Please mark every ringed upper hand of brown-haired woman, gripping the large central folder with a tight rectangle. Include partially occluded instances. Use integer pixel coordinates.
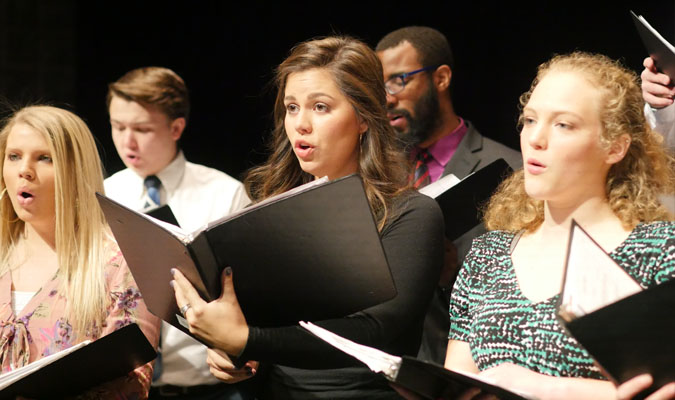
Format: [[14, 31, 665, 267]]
[[171, 267, 248, 356]]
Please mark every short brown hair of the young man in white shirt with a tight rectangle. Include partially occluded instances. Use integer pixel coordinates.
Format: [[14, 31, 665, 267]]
[[107, 67, 190, 121]]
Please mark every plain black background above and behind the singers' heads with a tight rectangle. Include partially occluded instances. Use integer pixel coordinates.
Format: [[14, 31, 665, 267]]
[[0, 0, 675, 178]]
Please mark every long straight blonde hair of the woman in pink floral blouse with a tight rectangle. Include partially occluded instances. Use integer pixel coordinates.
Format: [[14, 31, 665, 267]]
[[0, 106, 111, 336]]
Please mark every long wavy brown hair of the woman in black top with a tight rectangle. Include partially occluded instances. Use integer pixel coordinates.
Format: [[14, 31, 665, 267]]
[[244, 37, 408, 230]]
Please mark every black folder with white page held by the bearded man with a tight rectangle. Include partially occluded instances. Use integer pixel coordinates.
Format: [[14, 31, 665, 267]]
[[419, 158, 513, 240]]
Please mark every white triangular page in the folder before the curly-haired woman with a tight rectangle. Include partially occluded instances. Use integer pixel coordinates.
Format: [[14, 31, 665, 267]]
[[561, 225, 642, 317]]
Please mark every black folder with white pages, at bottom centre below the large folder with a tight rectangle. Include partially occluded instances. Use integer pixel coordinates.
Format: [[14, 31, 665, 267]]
[[300, 322, 534, 400]]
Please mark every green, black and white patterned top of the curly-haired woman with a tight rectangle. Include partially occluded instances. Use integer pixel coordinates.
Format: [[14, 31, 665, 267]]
[[449, 222, 675, 379]]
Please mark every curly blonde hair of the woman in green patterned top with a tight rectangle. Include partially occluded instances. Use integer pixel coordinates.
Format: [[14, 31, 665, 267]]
[[484, 52, 675, 232]]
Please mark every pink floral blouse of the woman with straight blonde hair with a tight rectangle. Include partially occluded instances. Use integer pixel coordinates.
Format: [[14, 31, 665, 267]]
[[0, 245, 160, 399]]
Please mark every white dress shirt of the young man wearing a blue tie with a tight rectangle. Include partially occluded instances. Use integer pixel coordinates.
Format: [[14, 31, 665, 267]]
[[105, 152, 250, 386]]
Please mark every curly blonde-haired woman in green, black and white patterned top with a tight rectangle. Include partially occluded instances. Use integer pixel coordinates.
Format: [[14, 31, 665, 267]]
[[446, 52, 675, 400]]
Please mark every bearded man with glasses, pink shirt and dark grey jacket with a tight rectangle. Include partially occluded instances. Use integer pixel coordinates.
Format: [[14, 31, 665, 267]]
[[375, 26, 522, 364]]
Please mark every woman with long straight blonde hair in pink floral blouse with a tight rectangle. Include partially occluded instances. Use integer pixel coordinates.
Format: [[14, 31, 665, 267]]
[[0, 106, 159, 398]]
